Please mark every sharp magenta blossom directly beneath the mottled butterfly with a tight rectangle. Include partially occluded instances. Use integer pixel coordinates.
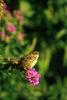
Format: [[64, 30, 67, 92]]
[[25, 68, 41, 86]]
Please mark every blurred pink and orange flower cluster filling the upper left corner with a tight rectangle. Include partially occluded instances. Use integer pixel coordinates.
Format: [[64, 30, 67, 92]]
[[0, 0, 26, 45]]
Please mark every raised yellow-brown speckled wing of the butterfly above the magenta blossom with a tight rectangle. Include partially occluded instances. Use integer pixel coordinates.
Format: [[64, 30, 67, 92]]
[[18, 51, 39, 69]]
